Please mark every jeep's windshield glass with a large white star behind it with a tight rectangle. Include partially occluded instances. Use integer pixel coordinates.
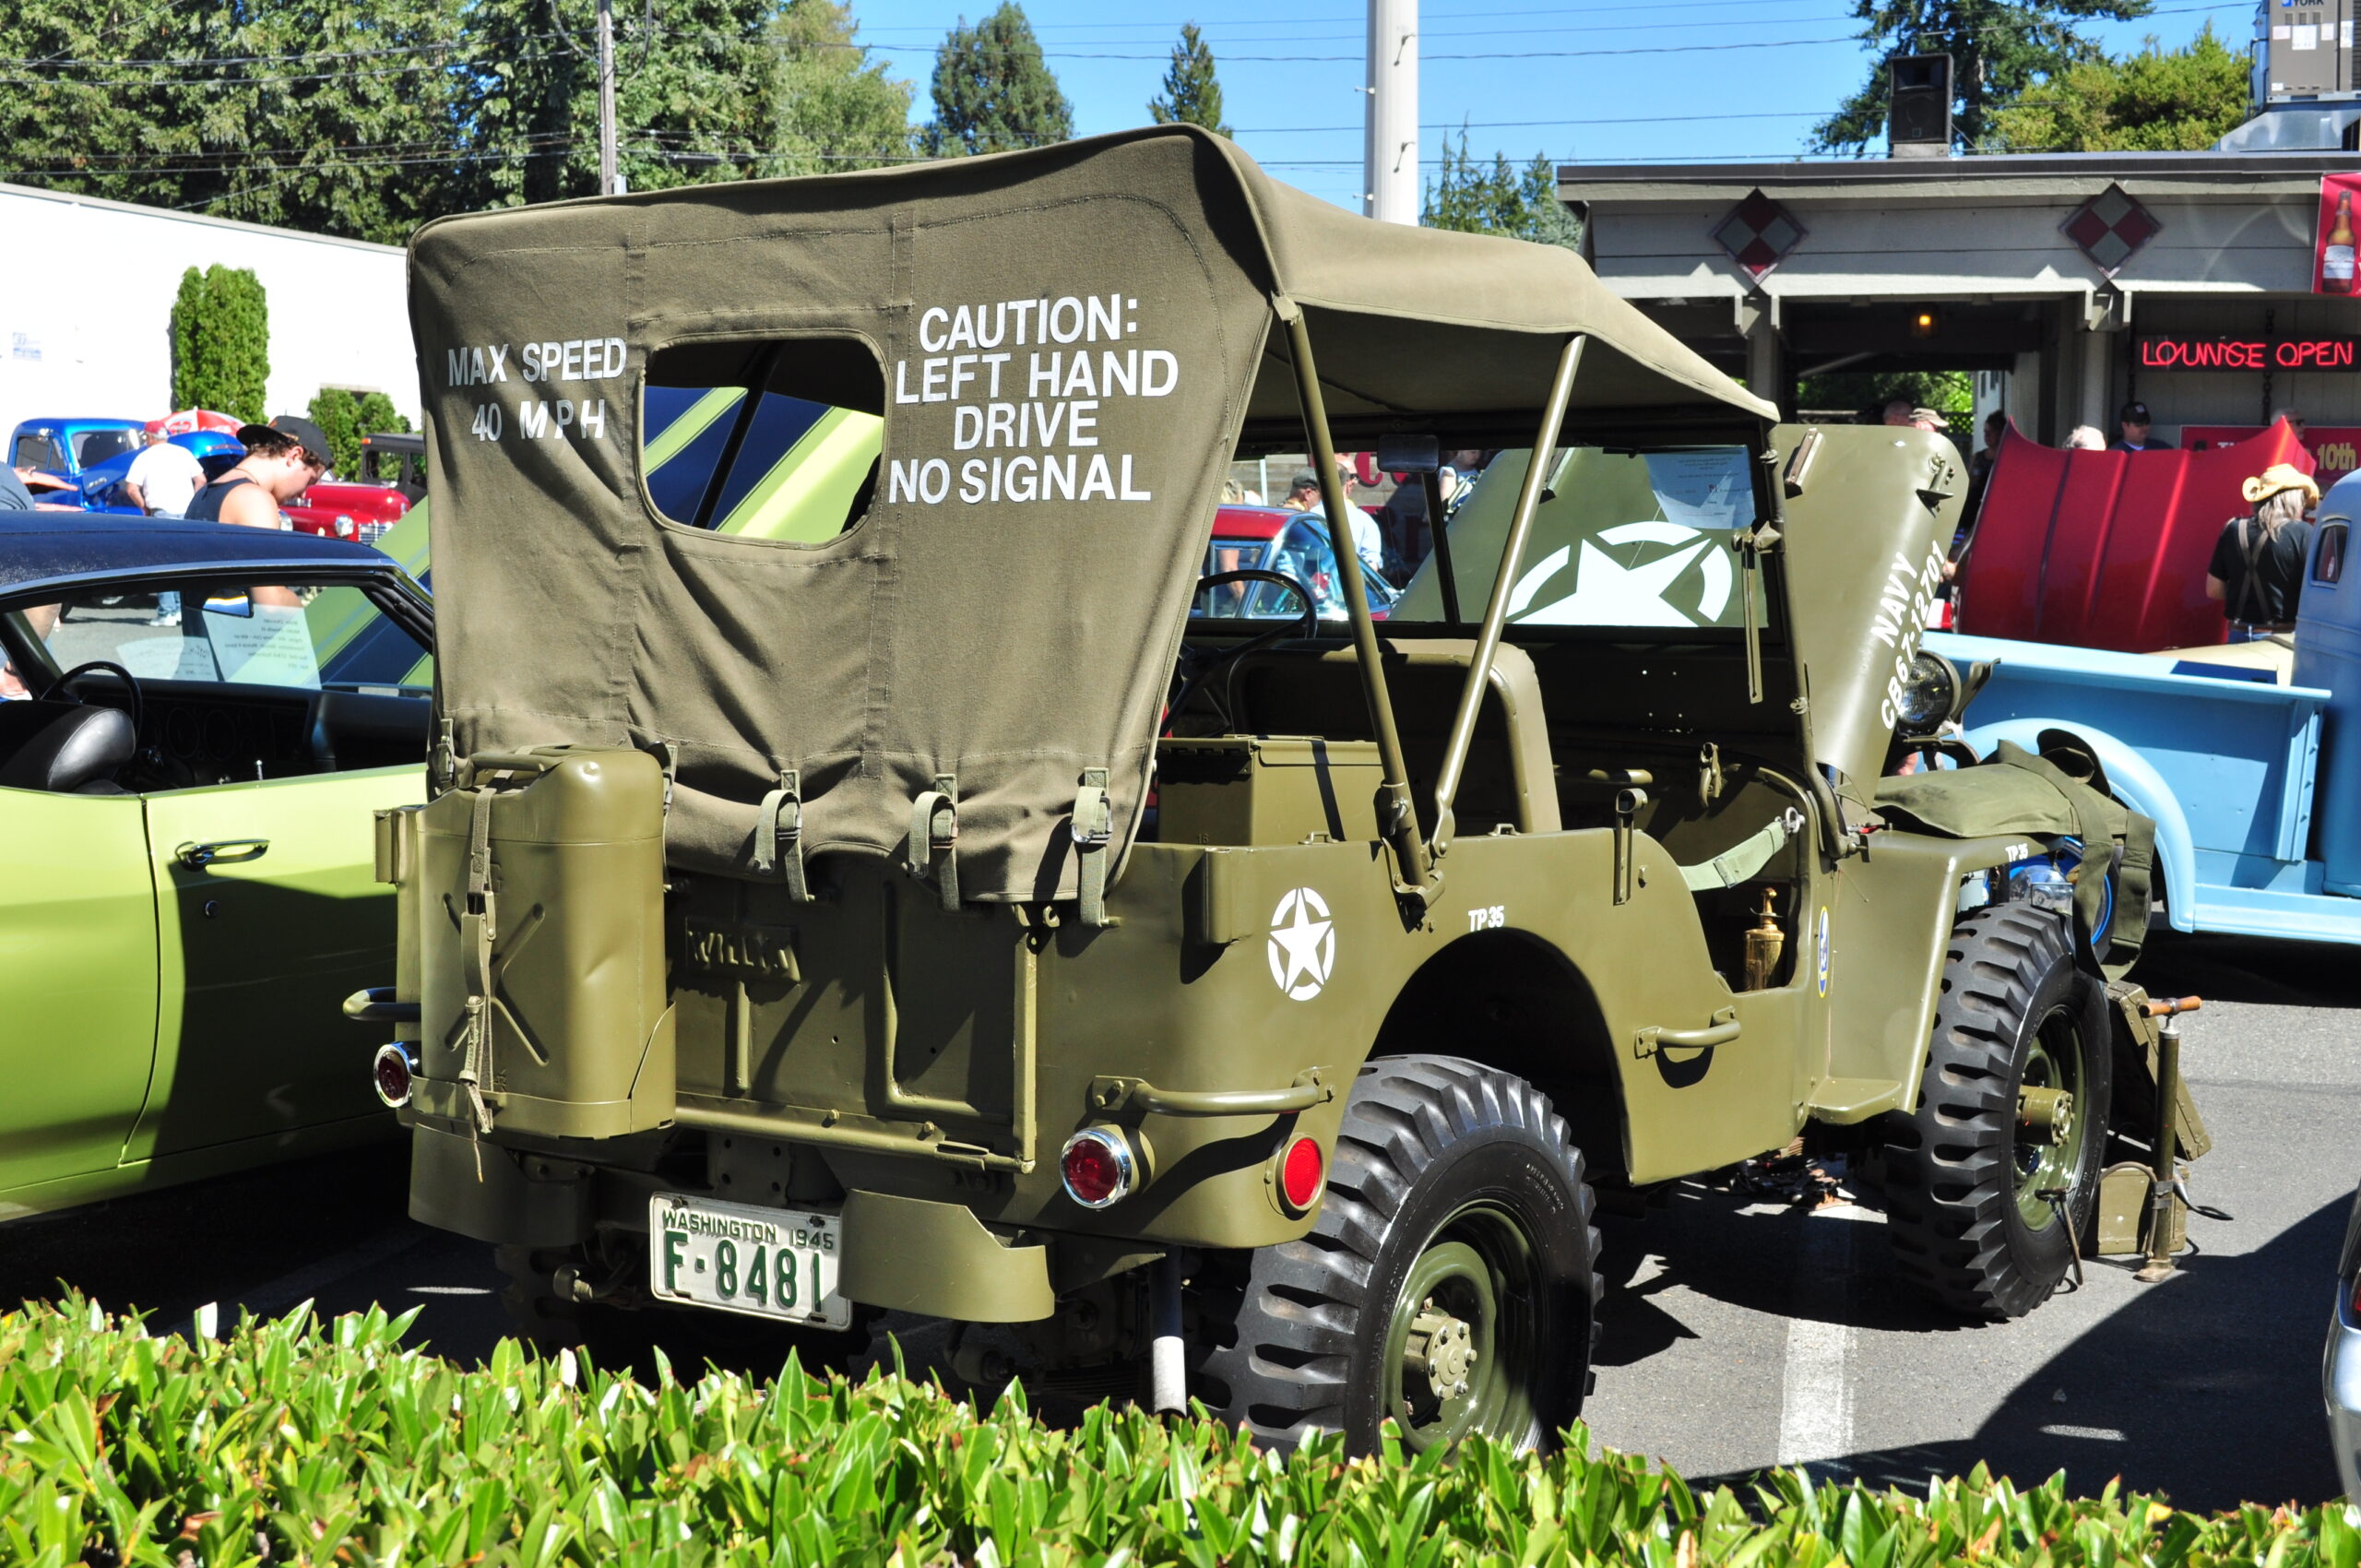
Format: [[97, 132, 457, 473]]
[[1391, 446, 1754, 631]]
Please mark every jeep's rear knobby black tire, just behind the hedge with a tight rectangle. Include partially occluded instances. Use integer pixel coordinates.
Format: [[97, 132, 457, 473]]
[[1192, 1055, 1598, 1453]]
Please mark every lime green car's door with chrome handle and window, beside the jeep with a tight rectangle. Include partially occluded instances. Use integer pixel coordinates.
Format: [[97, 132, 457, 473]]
[[30, 583, 430, 1167]]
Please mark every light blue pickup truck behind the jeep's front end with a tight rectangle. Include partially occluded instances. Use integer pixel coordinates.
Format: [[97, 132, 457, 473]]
[[1927, 472, 2361, 943]]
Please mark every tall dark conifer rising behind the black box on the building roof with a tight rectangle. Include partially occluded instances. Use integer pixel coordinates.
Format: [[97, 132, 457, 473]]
[[1813, 0, 2153, 153]]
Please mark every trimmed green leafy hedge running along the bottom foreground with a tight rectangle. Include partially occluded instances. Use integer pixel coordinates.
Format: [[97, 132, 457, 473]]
[[0, 1299, 2361, 1568]]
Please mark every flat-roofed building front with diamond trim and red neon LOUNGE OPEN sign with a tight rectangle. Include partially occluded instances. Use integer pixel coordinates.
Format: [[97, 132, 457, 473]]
[[1559, 151, 2361, 453]]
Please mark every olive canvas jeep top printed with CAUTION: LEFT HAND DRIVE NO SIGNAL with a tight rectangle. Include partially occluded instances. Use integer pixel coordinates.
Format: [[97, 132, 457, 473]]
[[410, 125, 1774, 899]]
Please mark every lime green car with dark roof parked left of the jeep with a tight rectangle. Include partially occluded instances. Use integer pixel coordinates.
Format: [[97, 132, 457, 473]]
[[0, 513, 432, 1218]]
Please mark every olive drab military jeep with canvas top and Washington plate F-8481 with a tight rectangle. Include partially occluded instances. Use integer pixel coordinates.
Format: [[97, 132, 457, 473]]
[[373, 125, 2143, 1445]]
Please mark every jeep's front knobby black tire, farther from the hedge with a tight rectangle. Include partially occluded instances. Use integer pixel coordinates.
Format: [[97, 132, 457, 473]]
[[1886, 905, 2113, 1320]]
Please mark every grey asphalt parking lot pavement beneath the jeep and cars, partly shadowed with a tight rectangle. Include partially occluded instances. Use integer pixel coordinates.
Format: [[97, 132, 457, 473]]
[[0, 940, 2361, 1506]]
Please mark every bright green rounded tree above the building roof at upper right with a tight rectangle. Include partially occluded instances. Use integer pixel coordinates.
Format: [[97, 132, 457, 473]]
[[1986, 21, 2250, 153]]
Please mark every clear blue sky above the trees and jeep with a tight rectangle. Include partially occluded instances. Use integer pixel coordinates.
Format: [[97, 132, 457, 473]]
[[852, 0, 2255, 210]]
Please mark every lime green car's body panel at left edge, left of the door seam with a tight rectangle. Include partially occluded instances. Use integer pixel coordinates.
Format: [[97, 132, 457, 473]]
[[0, 789, 156, 1199]]
